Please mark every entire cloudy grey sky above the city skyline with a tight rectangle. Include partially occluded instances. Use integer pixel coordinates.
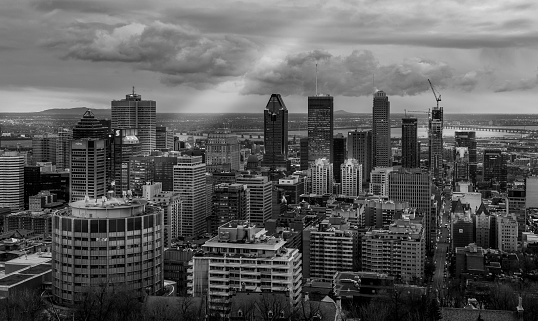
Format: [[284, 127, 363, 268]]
[[0, 0, 538, 113]]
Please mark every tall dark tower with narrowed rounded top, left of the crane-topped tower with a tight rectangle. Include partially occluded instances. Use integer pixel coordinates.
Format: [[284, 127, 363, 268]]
[[372, 90, 392, 167]]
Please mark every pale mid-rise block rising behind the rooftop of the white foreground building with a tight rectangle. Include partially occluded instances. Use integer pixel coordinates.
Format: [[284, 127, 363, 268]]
[[236, 175, 273, 226]]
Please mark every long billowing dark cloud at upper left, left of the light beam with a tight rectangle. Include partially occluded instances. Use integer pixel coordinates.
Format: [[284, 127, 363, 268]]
[[43, 22, 258, 88]]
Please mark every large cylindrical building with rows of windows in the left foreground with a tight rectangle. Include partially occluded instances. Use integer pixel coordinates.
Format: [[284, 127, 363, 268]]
[[52, 196, 164, 306]]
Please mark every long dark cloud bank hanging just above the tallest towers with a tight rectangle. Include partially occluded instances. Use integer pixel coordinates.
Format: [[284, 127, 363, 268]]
[[242, 50, 454, 96]]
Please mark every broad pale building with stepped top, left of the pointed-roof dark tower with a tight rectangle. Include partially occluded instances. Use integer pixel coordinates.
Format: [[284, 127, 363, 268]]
[[205, 130, 241, 172]]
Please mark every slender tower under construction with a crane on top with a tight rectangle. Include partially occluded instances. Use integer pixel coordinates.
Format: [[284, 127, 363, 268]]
[[428, 107, 443, 180]]
